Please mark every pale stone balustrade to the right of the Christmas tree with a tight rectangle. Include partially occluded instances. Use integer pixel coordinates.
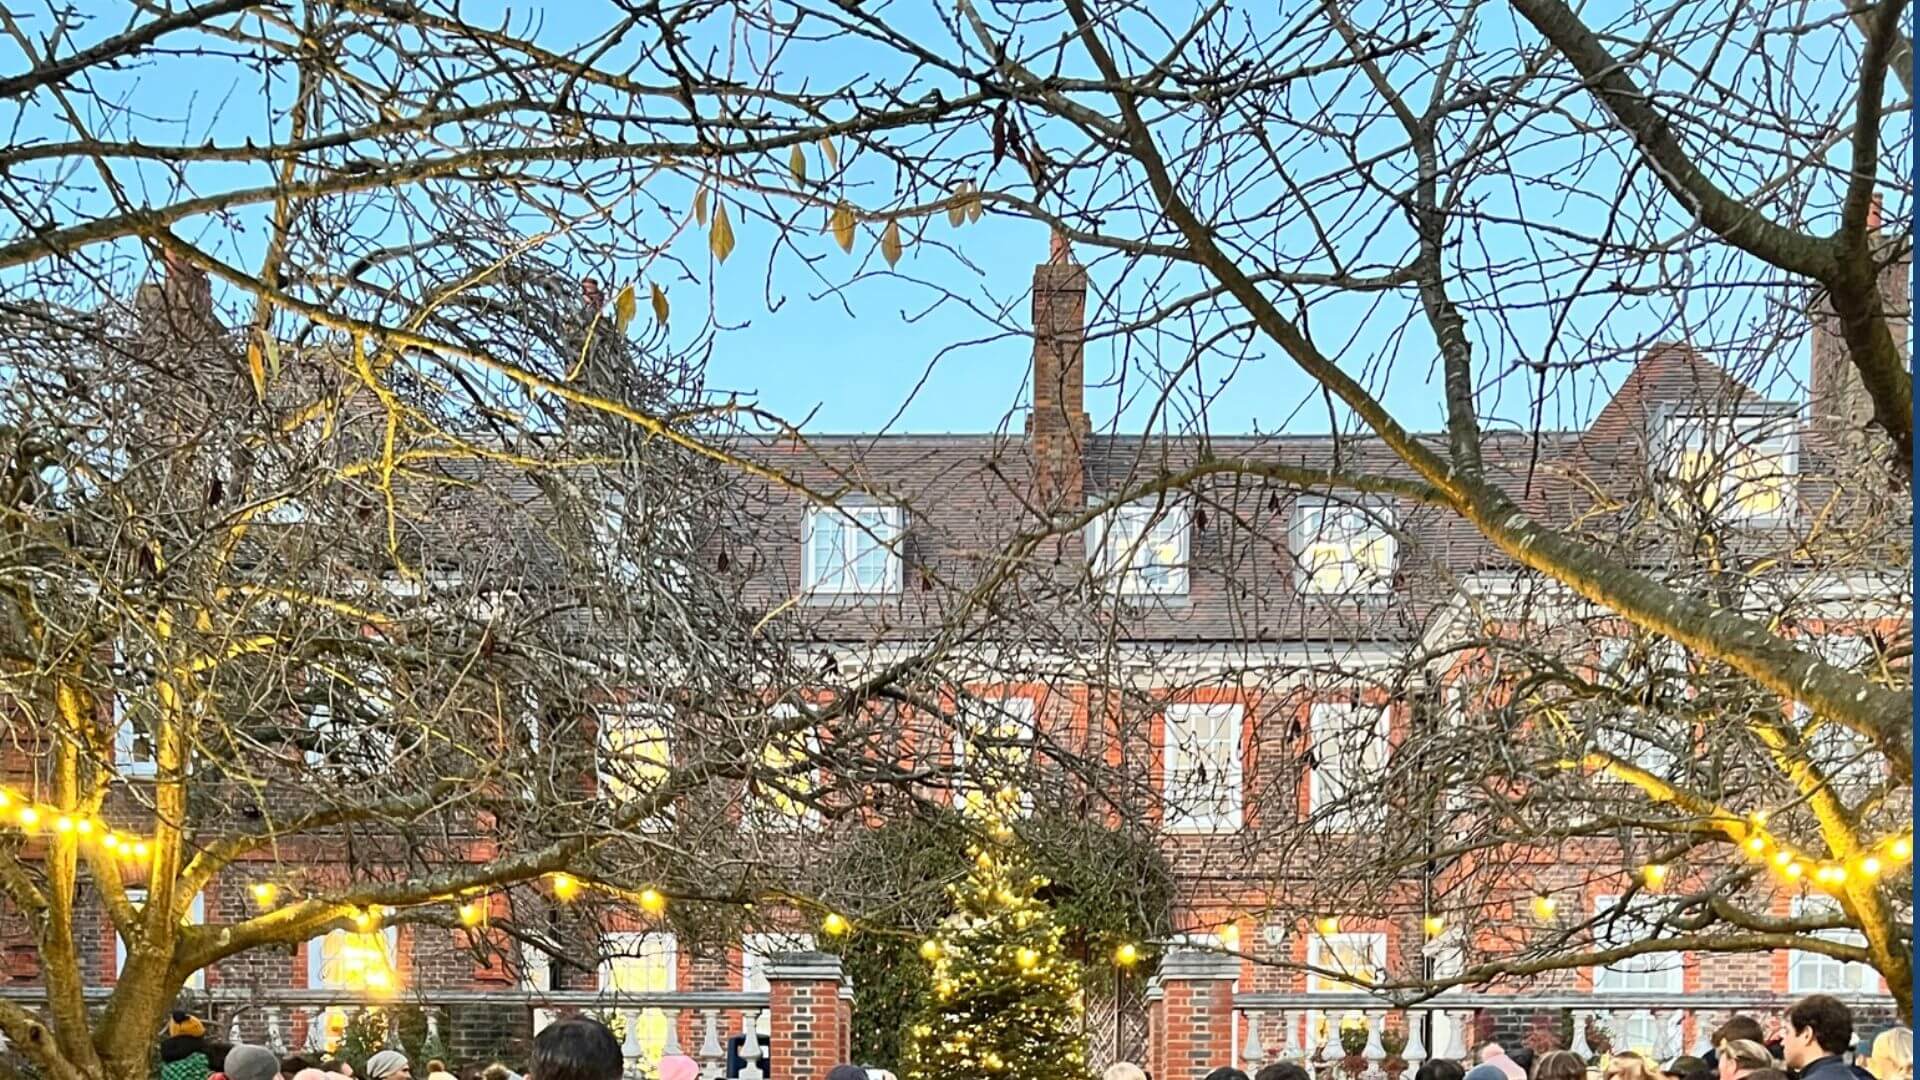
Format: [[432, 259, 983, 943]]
[[1235, 992, 1893, 1076]]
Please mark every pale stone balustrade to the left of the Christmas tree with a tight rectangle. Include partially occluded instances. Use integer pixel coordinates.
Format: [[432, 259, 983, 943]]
[[0, 986, 770, 1080]]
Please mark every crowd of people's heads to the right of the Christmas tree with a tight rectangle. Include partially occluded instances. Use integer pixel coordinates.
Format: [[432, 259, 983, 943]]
[[1102, 994, 1914, 1080]]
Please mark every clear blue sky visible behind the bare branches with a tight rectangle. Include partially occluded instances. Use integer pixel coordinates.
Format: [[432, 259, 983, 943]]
[[0, 0, 1904, 432]]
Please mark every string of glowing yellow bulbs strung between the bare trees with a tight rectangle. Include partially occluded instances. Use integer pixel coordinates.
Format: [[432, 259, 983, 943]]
[[0, 772, 1914, 949]]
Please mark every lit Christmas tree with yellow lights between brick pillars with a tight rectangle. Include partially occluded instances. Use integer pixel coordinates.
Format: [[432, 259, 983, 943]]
[[904, 780, 1087, 1080]]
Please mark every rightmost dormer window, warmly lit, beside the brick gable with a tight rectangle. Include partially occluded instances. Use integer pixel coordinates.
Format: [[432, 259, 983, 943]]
[[1657, 413, 1799, 523]]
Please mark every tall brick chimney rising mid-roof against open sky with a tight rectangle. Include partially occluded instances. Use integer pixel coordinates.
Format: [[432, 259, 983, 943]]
[[1027, 233, 1092, 509]]
